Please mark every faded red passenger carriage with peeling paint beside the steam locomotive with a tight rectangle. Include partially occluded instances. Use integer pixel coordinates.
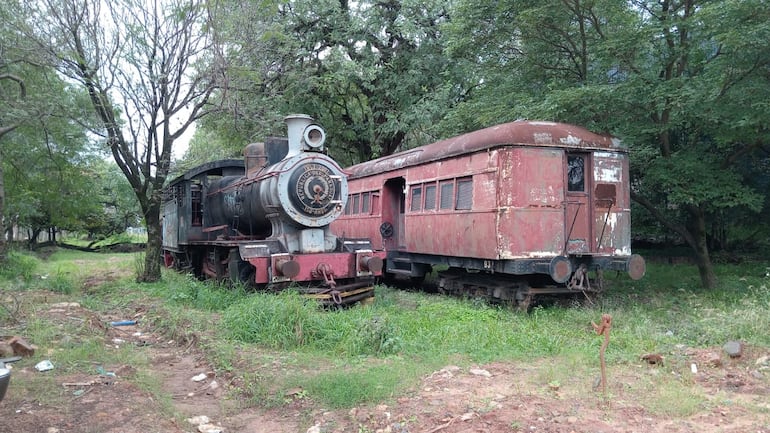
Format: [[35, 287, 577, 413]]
[[332, 121, 645, 306]]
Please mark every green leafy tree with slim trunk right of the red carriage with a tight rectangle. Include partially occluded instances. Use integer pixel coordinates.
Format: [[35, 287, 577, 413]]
[[450, 0, 769, 287]]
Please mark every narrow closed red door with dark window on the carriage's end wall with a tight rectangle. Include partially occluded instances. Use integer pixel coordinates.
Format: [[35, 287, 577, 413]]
[[564, 153, 593, 254]]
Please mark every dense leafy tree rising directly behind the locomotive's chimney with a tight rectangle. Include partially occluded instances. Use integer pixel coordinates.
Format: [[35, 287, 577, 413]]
[[204, 0, 449, 163]]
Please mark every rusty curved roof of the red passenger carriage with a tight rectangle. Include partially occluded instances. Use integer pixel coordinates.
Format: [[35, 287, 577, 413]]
[[345, 121, 627, 179]]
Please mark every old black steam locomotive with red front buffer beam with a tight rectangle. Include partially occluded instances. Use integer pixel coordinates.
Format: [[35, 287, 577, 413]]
[[162, 115, 385, 304]]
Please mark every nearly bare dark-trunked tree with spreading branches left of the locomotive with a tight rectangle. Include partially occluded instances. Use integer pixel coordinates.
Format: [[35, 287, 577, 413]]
[[25, 0, 221, 281]]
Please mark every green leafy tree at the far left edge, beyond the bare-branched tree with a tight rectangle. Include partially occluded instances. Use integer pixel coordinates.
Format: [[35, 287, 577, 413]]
[[0, 1, 102, 253]]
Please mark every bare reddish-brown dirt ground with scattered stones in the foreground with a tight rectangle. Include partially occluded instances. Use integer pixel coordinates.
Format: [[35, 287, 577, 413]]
[[0, 294, 770, 433]]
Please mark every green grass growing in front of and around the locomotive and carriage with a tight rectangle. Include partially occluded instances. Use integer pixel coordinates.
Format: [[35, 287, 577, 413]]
[[0, 251, 770, 416]]
